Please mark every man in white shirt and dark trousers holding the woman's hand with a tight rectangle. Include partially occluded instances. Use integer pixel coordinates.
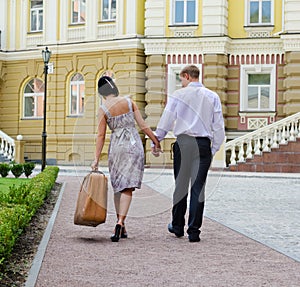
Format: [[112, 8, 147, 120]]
[[152, 65, 225, 242]]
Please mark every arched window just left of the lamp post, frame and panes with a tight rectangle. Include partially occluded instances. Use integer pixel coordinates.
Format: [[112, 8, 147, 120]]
[[23, 78, 44, 118]]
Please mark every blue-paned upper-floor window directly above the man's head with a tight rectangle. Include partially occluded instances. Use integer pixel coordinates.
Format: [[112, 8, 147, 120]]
[[172, 0, 198, 25]]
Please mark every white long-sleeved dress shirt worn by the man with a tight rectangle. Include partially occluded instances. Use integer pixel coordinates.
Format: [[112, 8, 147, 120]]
[[155, 82, 225, 155]]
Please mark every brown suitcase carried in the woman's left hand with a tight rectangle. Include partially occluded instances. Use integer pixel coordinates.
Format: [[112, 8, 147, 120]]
[[74, 171, 107, 227]]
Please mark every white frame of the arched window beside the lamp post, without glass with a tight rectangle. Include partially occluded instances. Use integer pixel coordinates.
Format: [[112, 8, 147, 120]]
[[22, 78, 45, 119]]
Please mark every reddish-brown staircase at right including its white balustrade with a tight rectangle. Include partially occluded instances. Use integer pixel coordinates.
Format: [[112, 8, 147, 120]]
[[225, 113, 300, 173]]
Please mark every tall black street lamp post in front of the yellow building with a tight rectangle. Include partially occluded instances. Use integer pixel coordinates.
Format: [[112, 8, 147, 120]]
[[42, 47, 51, 171]]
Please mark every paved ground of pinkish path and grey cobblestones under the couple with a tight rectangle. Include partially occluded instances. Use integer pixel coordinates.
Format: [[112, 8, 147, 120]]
[[26, 167, 300, 287]]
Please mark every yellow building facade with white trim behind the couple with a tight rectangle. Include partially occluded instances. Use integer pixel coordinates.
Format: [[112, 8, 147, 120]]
[[0, 0, 300, 166]]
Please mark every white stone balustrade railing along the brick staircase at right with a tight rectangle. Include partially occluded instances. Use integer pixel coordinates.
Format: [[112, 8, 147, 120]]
[[225, 112, 300, 165]]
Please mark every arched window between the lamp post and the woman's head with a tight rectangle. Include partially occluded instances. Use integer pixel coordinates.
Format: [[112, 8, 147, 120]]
[[70, 73, 85, 116]]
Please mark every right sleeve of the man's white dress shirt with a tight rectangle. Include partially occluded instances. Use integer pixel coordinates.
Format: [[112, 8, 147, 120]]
[[211, 96, 225, 155]]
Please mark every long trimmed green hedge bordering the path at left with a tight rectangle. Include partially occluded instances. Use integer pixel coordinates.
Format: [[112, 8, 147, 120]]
[[0, 166, 59, 267]]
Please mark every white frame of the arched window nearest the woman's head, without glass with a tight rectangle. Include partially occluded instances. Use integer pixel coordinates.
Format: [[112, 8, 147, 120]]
[[69, 73, 85, 117]]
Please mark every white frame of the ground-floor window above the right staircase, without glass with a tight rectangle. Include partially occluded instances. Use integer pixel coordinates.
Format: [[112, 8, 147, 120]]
[[240, 64, 276, 112]]
